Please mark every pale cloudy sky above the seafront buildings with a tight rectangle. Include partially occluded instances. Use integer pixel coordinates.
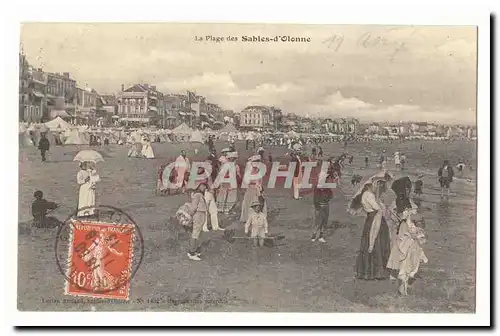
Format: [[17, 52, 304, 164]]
[[21, 23, 477, 124]]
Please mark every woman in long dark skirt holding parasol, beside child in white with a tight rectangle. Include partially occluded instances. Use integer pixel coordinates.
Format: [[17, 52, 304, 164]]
[[348, 171, 392, 280]]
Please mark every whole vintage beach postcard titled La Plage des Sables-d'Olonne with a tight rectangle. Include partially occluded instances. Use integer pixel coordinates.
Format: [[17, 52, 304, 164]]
[[9, 11, 489, 323]]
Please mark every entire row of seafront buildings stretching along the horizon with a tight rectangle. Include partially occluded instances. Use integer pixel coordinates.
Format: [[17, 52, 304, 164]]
[[19, 54, 477, 138]]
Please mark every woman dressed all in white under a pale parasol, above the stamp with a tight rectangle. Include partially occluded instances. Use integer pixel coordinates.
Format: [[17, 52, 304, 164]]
[[73, 150, 104, 217]]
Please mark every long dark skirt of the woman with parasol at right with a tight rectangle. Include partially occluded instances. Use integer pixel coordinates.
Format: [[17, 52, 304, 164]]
[[355, 212, 391, 280]]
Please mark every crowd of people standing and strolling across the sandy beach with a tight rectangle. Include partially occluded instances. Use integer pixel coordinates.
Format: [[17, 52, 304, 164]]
[[27, 130, 472, 295]]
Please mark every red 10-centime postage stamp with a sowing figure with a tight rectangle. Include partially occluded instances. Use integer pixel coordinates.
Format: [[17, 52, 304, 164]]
[[65, 220, 135, 300]]
